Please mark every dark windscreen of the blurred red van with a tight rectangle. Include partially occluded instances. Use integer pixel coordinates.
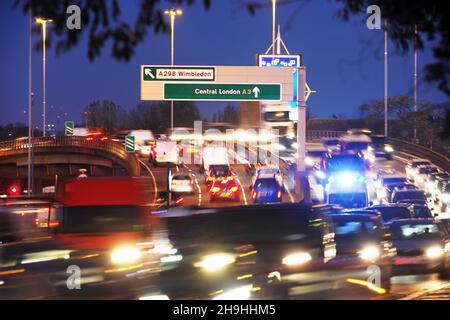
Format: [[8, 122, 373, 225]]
[[62, 206, 146, 233]]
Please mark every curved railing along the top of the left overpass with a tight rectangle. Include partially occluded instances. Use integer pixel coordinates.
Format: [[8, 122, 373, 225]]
[[0, 136, 139, 173]]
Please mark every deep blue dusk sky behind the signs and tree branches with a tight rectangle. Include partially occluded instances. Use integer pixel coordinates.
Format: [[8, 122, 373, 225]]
[[0, 0, 448, 129]]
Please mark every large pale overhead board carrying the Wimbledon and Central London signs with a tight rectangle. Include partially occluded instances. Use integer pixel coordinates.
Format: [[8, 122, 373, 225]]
[[141, 66, 304, 103]]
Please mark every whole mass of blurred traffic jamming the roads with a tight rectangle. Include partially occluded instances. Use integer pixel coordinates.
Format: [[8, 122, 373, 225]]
[[0, 128, 450, 300]]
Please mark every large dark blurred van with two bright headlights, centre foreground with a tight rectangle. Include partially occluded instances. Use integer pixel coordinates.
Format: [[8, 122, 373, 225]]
[[148, 204, 342, 300]]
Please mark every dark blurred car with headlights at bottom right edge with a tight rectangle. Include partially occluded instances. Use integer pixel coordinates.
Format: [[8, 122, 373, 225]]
[[387, 219, 450, 279]]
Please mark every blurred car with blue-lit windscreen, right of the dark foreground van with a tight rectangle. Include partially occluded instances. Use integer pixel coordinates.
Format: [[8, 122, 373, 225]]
[[329, 210, 395, 293]]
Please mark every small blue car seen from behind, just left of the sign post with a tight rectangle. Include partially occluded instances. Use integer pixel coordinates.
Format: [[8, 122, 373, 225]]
[[252, 174, 283, 203]]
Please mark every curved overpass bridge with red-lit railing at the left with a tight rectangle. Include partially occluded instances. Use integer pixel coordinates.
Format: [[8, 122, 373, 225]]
[[0, 136, 140, 189]]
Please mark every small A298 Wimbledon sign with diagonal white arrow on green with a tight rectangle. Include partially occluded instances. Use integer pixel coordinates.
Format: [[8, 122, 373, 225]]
[[142, 66, 216, 81]]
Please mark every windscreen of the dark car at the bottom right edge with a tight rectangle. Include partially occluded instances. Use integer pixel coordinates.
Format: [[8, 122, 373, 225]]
[[390, 223, 441, 240]]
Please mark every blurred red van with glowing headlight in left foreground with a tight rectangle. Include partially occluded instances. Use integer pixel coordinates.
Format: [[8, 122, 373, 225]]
[[0, 177, 165, 299]]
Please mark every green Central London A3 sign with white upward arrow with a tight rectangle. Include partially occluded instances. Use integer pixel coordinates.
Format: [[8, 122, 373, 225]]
[[164, 83, 281, 101]]
